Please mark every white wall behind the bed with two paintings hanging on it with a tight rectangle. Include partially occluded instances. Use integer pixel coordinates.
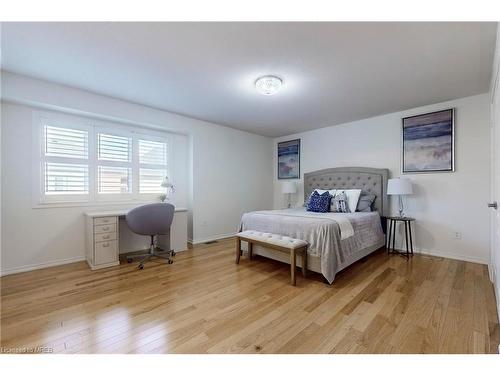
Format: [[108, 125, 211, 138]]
[[273, 94, 490, 263]]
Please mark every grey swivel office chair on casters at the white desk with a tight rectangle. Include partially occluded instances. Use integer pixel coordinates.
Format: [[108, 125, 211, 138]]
[[125, 203, 175, 270]]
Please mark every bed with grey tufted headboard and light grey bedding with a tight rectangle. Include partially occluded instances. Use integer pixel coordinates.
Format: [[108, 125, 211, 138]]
[[240, 167, 389, 283]]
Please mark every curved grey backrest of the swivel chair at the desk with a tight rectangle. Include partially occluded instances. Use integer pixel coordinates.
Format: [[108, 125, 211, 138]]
[[125, 203, 175, 236]]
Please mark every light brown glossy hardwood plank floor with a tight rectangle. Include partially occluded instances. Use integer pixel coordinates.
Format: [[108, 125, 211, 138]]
[[1, 239, 500, 353]]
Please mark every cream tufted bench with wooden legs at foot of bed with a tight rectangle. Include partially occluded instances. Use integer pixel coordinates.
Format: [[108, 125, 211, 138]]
[[236, 230, 308, 285]]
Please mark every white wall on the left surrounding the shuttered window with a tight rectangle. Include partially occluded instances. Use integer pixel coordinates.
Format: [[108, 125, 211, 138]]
[[1, 72, 272, 273]]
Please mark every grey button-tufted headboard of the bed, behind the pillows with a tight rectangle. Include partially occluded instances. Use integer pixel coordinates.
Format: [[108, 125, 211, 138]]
[[304, 167, 389, 216]]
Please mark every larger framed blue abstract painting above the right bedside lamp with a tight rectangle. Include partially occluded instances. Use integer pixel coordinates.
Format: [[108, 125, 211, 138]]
[[402, 109, 455, 173]]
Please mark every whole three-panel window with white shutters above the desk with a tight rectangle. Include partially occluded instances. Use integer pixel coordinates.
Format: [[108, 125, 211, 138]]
[[34, 115, 171, 209]]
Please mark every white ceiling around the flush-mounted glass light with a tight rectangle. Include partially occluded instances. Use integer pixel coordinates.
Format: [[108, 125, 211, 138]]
[[2, 23, 496, 136]]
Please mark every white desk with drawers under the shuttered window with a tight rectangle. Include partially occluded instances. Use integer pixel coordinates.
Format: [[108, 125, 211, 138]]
[[85, 207, 187, 270]]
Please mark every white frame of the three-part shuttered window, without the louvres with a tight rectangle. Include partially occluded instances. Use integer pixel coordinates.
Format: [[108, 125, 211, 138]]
[[32, 112, 173, 212]]
